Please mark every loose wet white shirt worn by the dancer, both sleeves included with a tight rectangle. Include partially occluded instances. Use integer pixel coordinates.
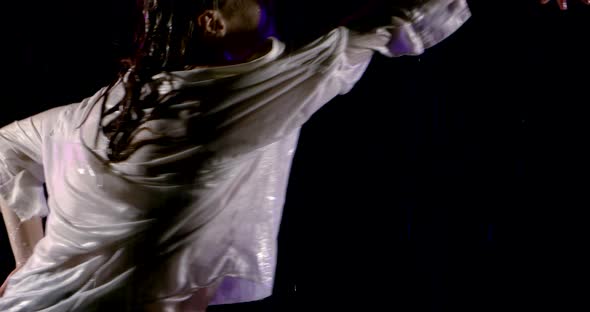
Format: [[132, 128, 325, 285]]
[[0, 0, 469, 311]]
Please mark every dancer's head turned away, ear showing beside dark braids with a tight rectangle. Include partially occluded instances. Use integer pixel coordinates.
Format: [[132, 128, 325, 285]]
[[135, 0, 272, 70]]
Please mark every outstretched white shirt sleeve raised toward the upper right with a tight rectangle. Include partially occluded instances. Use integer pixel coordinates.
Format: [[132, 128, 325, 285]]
[[166, 0, 469, 158]]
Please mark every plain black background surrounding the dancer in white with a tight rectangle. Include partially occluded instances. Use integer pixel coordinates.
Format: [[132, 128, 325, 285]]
[[0, 0, 590, 311]]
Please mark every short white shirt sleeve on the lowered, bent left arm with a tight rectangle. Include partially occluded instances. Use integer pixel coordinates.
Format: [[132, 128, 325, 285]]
[[0, 109, 59, 221]]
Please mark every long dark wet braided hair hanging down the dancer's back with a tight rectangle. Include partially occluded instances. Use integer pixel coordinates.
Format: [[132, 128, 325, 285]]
[[101, 0, 227, 162]]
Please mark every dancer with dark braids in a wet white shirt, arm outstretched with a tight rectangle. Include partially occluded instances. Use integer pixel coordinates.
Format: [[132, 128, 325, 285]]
[[0, 0, 584, 311]]
